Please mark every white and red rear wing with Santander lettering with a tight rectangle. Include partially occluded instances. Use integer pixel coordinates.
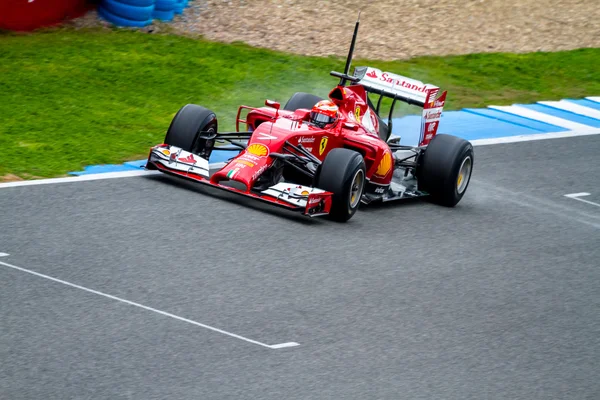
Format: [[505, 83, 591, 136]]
[[353, 67, 447, 146]]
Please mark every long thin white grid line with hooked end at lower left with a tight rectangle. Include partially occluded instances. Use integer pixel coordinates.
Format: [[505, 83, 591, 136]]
[[0, 261, 299, 349]]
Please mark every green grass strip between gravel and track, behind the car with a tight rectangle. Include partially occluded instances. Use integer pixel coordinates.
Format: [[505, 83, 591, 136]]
[[0, 29, 600, 178]]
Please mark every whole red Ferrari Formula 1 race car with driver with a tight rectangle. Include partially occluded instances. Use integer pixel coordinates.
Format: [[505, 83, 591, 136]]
[[146, 15, 474, 222]]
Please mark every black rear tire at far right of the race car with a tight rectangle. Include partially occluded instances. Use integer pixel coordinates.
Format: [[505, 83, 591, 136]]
[[417, 134, 475, 207]]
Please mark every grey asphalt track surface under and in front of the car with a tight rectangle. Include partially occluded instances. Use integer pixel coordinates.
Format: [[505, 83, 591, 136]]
[[0, 135, 600, 400]]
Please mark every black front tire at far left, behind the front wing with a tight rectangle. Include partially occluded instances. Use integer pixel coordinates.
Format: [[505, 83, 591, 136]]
[[165, 104, 218, 160]]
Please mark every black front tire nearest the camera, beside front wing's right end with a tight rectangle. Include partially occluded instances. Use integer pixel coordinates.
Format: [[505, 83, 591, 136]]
[[316, 148, 366, 222]]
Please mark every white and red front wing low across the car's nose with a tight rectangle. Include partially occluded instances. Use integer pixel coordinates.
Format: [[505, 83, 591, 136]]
[[146, 145, 332, 217]]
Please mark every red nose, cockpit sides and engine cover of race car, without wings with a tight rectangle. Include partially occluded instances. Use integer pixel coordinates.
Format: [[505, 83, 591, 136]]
[[211, 85, 394, 188]]
